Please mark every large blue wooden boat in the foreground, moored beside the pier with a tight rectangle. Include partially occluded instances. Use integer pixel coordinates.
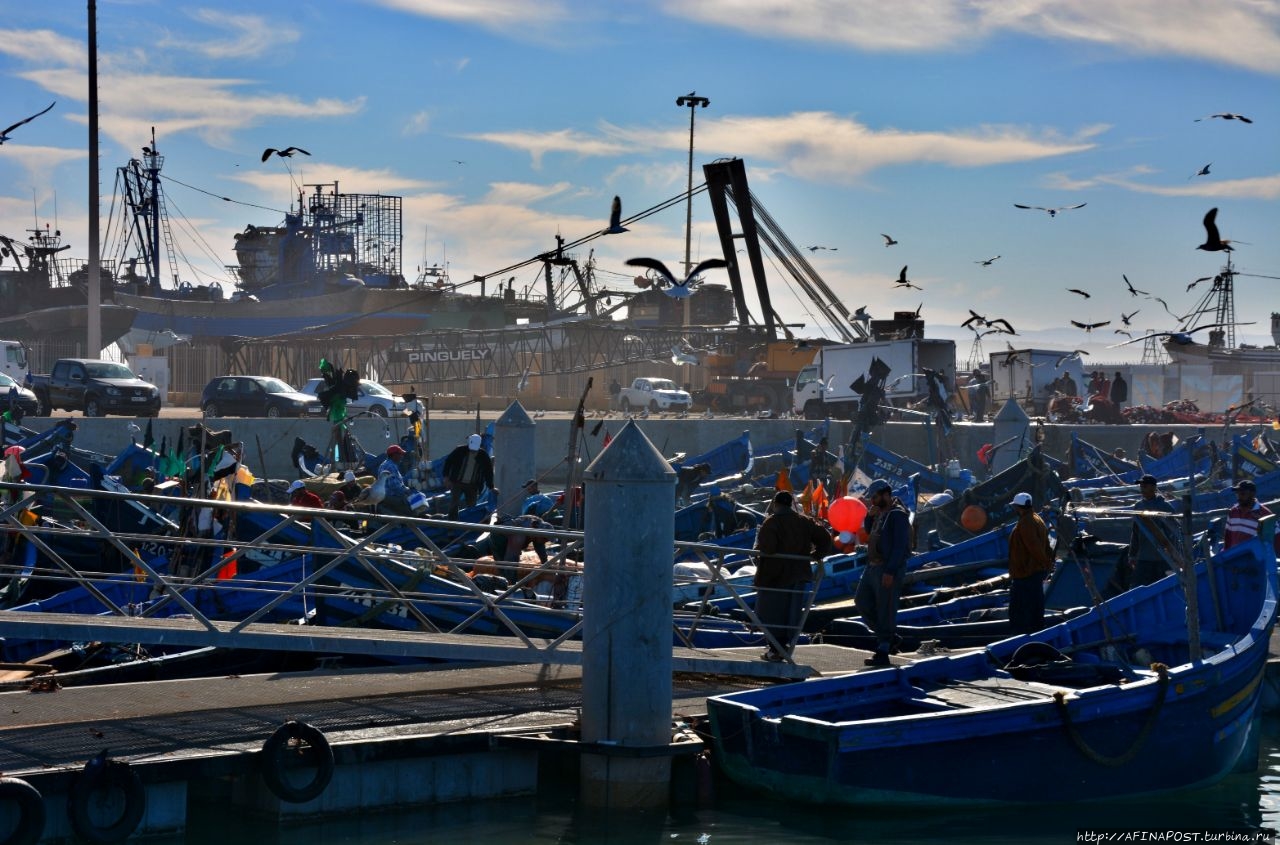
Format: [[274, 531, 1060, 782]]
[[708, 517, 1276, 808]]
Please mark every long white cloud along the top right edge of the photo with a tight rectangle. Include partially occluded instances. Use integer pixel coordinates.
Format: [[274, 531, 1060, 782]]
[[663, 0, 1280, 73]]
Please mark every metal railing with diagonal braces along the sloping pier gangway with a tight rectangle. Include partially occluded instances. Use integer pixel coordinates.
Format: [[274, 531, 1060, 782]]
[[0, 483, 777, 671]]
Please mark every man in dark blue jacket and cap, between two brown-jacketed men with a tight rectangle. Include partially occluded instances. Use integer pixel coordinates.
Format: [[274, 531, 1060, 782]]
[[854, 479, 911, 666]]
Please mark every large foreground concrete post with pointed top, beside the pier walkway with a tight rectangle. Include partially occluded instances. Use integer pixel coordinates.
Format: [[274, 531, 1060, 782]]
[[581, 420, 676, 810]]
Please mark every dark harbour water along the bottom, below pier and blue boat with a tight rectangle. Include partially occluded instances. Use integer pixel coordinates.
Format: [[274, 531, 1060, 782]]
[[167, 716, 1280, 845]]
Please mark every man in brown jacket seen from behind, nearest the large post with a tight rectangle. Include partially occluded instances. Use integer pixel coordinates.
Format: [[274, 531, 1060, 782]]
[[755, 490, 831, 661]]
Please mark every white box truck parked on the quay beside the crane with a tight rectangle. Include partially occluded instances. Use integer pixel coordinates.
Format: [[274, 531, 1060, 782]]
[[792, 338, 956, 420]]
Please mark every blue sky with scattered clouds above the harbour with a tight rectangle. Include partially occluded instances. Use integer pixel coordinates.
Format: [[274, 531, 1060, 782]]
[[0, 0, 1280, 362]]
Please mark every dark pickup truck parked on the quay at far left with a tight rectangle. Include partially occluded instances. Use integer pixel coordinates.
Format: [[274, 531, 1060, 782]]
[[28, 358, 160, 416]]
